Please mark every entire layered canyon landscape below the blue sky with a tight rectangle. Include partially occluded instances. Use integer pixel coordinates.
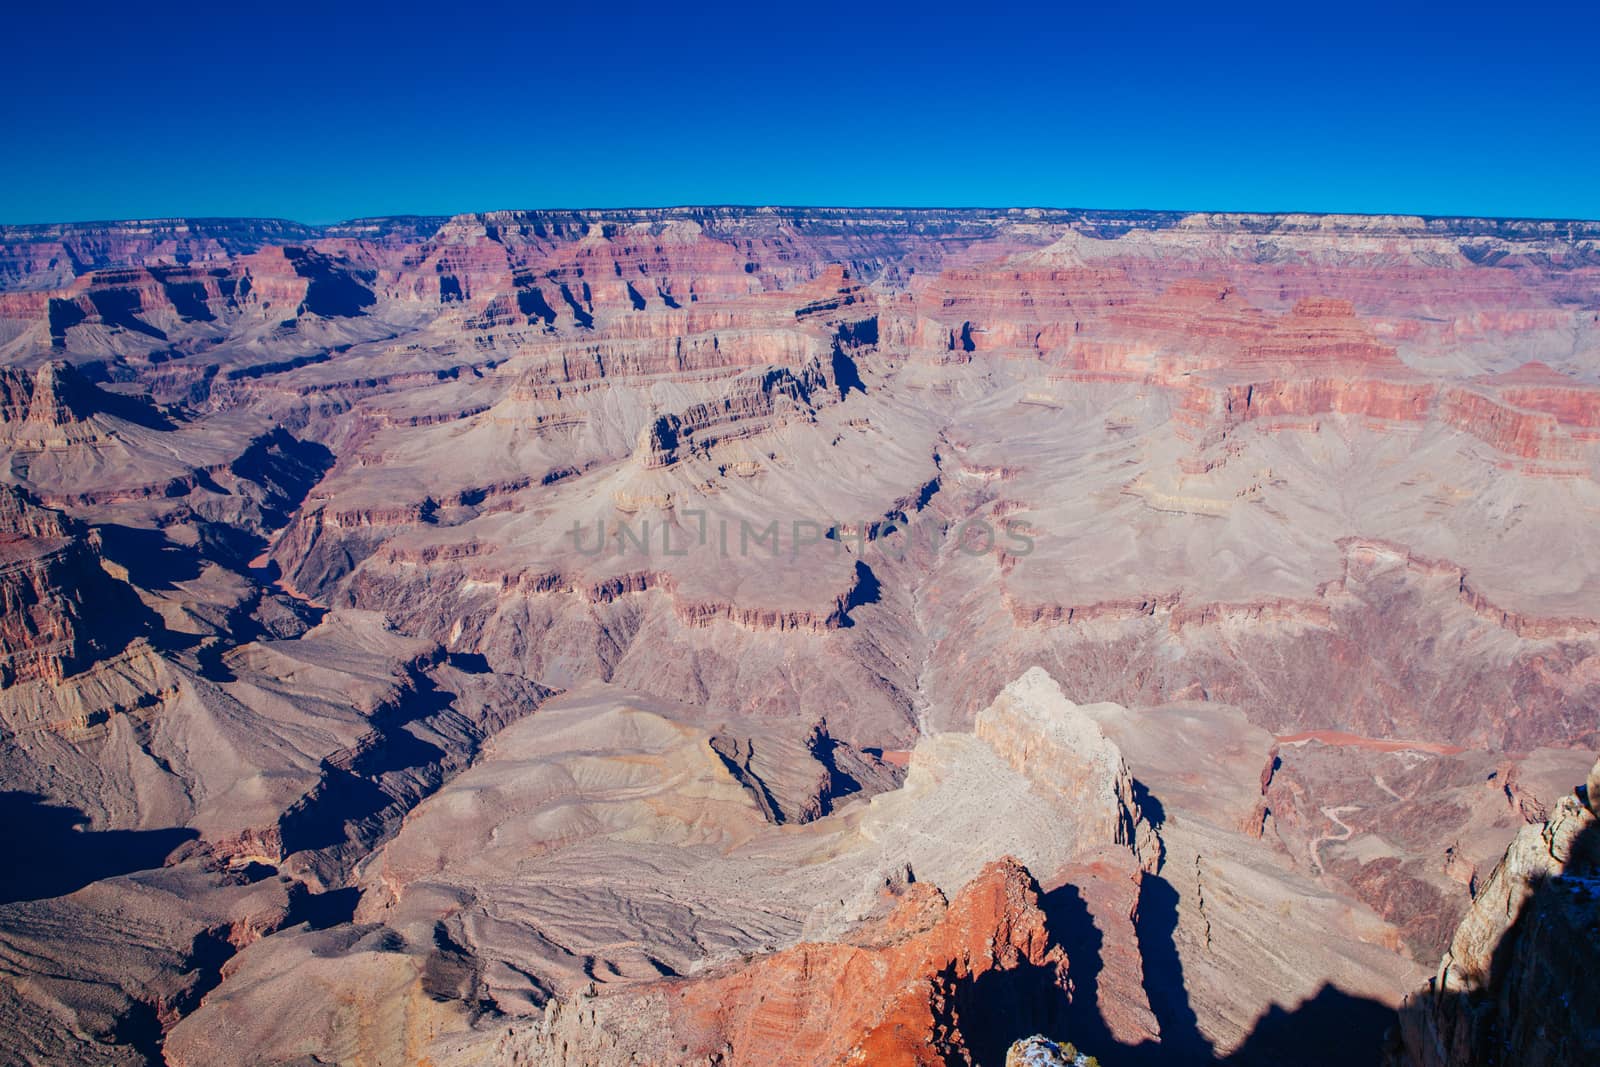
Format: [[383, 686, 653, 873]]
[[0, 208, 1600, 1067]]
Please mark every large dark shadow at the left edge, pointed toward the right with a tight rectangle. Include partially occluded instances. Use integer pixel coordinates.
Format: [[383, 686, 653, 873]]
[[0, 792, 200, 904]]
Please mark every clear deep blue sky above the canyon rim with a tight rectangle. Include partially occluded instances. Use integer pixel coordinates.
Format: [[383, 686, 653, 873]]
[[0, 0, 1600, 222]]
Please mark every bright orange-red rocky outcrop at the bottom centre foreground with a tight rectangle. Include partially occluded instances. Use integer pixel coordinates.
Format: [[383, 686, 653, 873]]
[[490, 859, 1069, 1067]]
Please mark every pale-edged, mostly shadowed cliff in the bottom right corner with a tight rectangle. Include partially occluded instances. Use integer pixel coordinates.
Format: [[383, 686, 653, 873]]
[[1397, 763, 1600, 1067]]
